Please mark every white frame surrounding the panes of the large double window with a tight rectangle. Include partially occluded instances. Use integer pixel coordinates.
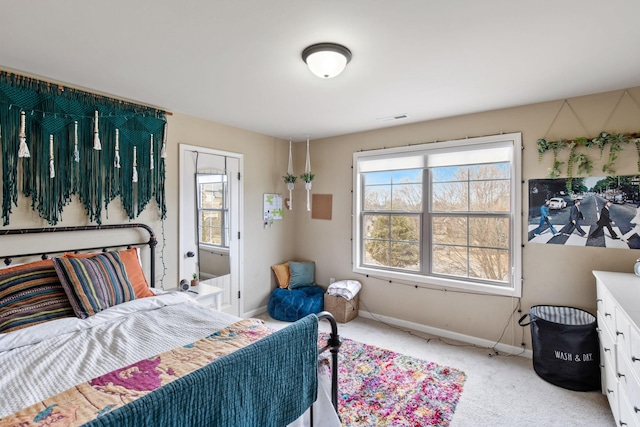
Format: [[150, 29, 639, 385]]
[[352, 133, 522, 297]]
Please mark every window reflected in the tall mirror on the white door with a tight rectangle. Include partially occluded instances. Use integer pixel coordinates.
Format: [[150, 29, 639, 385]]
[[197, 174, 229, 248]]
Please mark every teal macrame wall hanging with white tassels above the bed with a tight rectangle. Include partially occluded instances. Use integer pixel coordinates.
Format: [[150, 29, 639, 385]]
[[0, 71, 167, 225]]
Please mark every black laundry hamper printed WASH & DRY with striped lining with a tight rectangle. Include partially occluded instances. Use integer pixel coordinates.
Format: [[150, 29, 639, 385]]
[[518, 305, 601, 391]]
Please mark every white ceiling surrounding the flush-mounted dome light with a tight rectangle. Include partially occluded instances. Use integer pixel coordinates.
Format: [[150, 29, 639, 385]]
[[0, 0, 640, 141]]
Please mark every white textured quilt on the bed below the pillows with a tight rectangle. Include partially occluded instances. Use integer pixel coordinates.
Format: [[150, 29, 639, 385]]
[[0, 293, 238, 417]]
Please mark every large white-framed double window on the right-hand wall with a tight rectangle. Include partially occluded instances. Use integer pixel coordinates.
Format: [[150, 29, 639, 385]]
[[353, 133, 521, 296]]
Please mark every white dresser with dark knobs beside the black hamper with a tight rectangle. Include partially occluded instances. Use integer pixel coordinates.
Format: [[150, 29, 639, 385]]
[[593, 271, 640, 427]]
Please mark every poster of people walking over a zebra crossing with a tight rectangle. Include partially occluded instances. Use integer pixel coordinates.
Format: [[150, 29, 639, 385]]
[[527, 176, 640, 249]]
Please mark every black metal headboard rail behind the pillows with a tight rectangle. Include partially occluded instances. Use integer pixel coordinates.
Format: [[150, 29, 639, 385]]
[[0, 223, 158, 287]]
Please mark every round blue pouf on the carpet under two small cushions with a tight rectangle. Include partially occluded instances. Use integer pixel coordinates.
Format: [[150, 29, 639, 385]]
[[267, 286, 324, 322]]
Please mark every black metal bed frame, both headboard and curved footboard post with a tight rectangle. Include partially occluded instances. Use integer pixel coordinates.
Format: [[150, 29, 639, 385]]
[[0, 223, 342, 426]]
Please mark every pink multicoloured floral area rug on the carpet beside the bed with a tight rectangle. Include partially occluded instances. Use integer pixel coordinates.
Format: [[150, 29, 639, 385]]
[[320, 333, 466, 427]]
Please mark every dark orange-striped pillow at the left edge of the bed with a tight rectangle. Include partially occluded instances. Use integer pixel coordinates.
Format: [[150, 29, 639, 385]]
[[0, 259, 74, 333]]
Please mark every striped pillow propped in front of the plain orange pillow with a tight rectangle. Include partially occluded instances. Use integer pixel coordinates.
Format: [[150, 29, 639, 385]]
[[53, 252, 136, 319]]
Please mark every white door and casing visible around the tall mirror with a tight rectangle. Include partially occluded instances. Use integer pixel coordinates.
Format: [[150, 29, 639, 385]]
[[178, 143, 244, 317]]
